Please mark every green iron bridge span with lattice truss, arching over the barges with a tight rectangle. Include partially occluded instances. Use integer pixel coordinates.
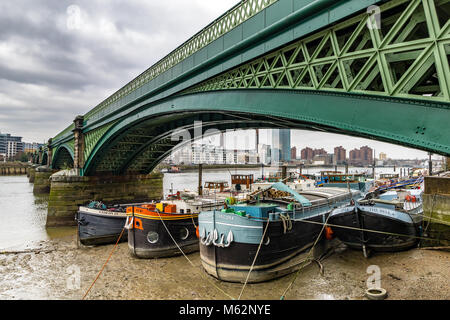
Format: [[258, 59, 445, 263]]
[[52, 0, 450, 175]]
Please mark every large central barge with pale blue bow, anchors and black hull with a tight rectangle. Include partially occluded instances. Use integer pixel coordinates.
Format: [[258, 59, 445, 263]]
[[199, 183, 360, 282]]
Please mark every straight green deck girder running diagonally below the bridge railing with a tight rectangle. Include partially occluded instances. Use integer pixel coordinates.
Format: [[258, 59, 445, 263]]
[[54, 0, 366, 143]]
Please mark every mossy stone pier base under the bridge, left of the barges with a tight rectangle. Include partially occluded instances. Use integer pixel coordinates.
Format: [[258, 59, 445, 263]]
[[47, 170, 163, 227]]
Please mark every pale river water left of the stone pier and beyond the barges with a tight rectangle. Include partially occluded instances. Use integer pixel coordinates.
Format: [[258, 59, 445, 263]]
[[0, 167, 400, 251]]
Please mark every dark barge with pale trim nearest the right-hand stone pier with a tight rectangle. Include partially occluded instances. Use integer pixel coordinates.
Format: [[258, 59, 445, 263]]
[[328, 189, 423, 257]]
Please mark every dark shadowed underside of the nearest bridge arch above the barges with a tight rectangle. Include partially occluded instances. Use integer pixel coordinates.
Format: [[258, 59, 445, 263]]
[[86, 111, 316, 175]]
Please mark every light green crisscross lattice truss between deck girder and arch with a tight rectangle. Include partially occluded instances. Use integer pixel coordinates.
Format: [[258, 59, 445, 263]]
[[185, 0, 450, 102]]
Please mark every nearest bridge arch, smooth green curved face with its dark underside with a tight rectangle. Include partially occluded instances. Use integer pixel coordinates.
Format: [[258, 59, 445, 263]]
[[83, 89, 450, 175]]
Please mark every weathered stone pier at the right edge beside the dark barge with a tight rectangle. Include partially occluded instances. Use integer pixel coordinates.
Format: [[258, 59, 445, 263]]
[[421, 177, 450, 247]]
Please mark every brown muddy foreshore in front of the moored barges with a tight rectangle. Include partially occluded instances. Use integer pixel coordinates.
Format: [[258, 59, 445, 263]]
[[0, 228, 450, 300]]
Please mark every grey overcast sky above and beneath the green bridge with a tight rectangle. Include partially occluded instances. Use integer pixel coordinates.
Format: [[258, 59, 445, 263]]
[[0, 0, 436, 158]]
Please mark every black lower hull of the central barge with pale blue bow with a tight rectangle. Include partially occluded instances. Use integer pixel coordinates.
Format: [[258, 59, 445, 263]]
[[200, 215, 326, 283]]
